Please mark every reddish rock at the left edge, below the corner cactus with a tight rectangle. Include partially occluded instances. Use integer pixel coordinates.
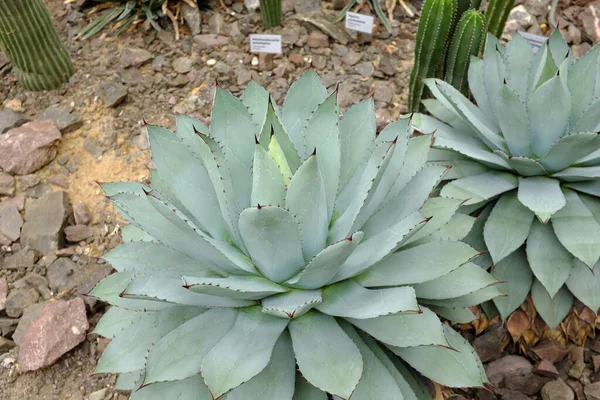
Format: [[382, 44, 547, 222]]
[[0, 120, 61, 175]]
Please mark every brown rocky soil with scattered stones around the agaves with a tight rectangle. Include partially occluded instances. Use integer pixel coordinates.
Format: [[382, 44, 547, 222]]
[[0, 0, 600, 400]]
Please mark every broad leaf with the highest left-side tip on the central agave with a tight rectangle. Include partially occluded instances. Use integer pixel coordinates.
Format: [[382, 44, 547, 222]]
[[148, 126, 227, 239]]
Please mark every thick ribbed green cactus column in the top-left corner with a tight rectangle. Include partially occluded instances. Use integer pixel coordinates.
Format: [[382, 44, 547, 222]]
[[0, 0, 73, 91]]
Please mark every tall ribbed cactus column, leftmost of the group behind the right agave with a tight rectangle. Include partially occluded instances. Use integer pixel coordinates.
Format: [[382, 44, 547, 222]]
[[408, 0, 458, 111]]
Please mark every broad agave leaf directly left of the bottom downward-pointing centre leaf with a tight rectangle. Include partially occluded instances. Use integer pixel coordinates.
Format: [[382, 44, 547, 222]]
[[201, 307, 288, 398]]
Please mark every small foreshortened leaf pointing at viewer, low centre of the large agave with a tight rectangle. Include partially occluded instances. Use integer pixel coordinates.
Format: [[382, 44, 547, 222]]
[[262, 289, 323, 318]]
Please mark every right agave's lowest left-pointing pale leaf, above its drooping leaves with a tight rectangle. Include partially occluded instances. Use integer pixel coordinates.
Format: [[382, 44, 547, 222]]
[[441, 171, 518, 205]]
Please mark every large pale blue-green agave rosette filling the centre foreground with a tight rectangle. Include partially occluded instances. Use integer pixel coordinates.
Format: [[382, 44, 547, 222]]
[[91, 70, 499, 400]]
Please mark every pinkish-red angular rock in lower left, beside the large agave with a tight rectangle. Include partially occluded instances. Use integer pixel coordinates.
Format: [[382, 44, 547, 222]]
[[19, 298, 89, 371]]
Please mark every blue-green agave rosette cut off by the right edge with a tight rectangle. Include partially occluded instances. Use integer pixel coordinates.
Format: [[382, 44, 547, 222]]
[[413, 31, 600, 327]]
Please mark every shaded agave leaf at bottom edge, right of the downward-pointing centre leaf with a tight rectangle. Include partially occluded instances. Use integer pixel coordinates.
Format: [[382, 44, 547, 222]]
[[340, 321, 408, 399]]
